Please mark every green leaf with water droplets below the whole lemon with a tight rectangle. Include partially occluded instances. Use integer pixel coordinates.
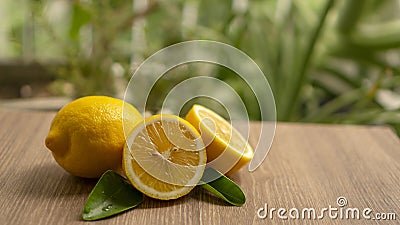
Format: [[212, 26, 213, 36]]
[[82, 170, 143, 220]]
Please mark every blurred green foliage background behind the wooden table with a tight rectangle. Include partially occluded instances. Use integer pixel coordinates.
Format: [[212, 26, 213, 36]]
[[0, 0, 400, 133]]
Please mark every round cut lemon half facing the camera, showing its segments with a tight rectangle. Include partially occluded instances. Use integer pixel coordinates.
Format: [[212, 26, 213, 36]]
[[123, 115, 207, 200]]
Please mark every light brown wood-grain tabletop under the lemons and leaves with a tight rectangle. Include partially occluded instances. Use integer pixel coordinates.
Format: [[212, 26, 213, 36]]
[[0, 109, 400, 225]]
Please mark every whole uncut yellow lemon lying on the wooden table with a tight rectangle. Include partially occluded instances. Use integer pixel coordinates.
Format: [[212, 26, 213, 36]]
[[45, 96, 143, 178]]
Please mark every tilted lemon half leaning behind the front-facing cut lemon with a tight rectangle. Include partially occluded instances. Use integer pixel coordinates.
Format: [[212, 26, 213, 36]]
[[186, 105, 253, 175]]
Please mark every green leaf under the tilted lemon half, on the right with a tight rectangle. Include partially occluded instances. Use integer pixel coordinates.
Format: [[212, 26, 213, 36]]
[[200, 167, 246, 206]]
